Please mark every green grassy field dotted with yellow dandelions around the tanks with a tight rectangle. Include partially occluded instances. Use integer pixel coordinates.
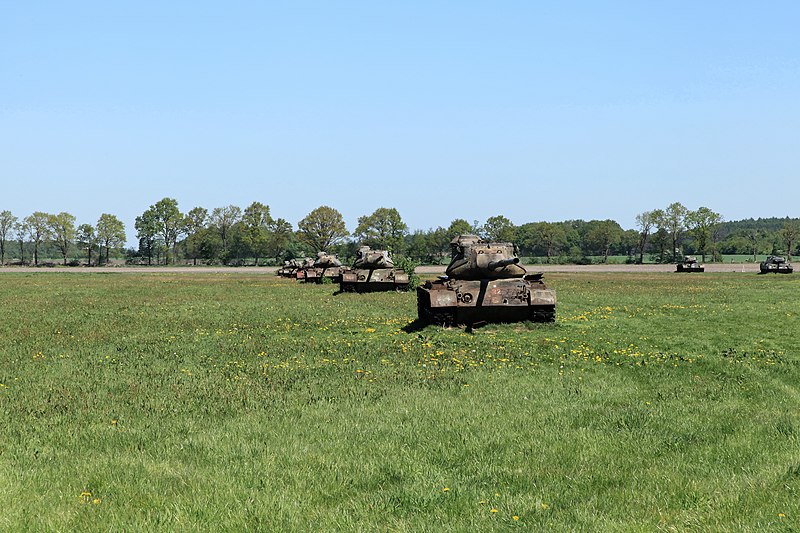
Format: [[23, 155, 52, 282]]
[[0, 273, 800, 531]]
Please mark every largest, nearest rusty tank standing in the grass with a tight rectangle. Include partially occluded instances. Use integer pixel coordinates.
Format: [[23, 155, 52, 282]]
[[417, 235, 556, 326]]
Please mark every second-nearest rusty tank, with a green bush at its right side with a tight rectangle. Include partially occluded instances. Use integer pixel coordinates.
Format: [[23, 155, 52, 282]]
[[339, 246, 408, 292]]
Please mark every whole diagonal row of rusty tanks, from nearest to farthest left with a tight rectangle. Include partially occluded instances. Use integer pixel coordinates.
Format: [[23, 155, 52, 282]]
[[278, 235, 556, 326]]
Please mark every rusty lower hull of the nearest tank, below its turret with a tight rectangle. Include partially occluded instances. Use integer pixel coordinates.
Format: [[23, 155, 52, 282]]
[[417, 278, 556, 326]]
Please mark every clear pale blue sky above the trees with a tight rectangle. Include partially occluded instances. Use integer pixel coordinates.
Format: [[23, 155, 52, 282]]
[[0, 0, 800, 244]]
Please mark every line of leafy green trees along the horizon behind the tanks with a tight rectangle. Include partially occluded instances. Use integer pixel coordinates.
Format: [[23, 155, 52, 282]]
[[0, 198, 800, 265]]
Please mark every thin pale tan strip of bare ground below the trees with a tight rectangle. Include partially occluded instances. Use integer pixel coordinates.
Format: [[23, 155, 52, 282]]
[[0, 263, 758, 274]]
